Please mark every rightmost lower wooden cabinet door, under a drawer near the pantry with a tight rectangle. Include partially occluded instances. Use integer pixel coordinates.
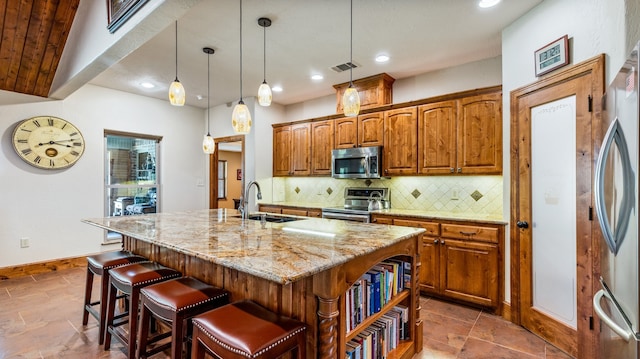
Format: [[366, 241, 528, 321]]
[[440, 239, 499, 307]]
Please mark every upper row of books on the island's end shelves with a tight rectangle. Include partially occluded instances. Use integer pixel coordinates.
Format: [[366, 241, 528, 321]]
[[345, 259, 411, 332]]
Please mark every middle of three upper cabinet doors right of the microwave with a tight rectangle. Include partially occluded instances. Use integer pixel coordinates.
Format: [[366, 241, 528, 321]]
[[418, 100, 458, 174]]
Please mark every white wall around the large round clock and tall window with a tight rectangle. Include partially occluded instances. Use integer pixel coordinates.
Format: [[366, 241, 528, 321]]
[[0, 85, 208, 267]]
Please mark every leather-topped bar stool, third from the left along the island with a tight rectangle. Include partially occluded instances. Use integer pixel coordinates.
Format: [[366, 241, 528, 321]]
[[136, 277, 229, 359]]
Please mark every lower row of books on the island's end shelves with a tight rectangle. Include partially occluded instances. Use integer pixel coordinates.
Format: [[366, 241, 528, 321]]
[[346, 305, 410, 359]]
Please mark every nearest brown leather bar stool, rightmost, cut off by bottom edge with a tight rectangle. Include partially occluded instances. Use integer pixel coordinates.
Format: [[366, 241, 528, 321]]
[[191, 300, 306, 359]]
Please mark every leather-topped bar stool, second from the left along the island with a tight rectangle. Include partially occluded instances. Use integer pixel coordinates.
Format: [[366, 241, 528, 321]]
[[104, 262, 181, 359]]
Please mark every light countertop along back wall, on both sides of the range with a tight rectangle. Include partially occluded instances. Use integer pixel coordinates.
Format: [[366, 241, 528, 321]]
[[260, 202, 508, 224]]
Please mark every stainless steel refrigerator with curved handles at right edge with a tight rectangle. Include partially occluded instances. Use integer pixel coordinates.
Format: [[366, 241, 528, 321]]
[[593, 43, 640, 359]]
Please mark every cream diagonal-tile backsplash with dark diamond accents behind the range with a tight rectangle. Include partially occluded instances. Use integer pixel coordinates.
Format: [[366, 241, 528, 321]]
[[273, 176, 503, 216]]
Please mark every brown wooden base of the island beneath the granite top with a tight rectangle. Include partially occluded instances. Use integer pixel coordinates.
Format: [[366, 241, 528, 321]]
[[123, 234, 422, 359]]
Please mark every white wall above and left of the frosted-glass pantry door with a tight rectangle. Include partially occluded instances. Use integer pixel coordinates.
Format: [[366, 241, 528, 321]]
[[502, 0, 638, 301]]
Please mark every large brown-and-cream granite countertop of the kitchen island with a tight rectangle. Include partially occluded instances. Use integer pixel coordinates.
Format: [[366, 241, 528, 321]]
[[82, 209, 424, 284]]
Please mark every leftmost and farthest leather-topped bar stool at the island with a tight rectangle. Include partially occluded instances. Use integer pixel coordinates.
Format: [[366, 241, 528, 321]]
[[82, 251, 148, 345]]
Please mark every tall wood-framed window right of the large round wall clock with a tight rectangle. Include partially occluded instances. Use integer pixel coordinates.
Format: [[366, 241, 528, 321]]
[[104, 131, 161, 242]]
